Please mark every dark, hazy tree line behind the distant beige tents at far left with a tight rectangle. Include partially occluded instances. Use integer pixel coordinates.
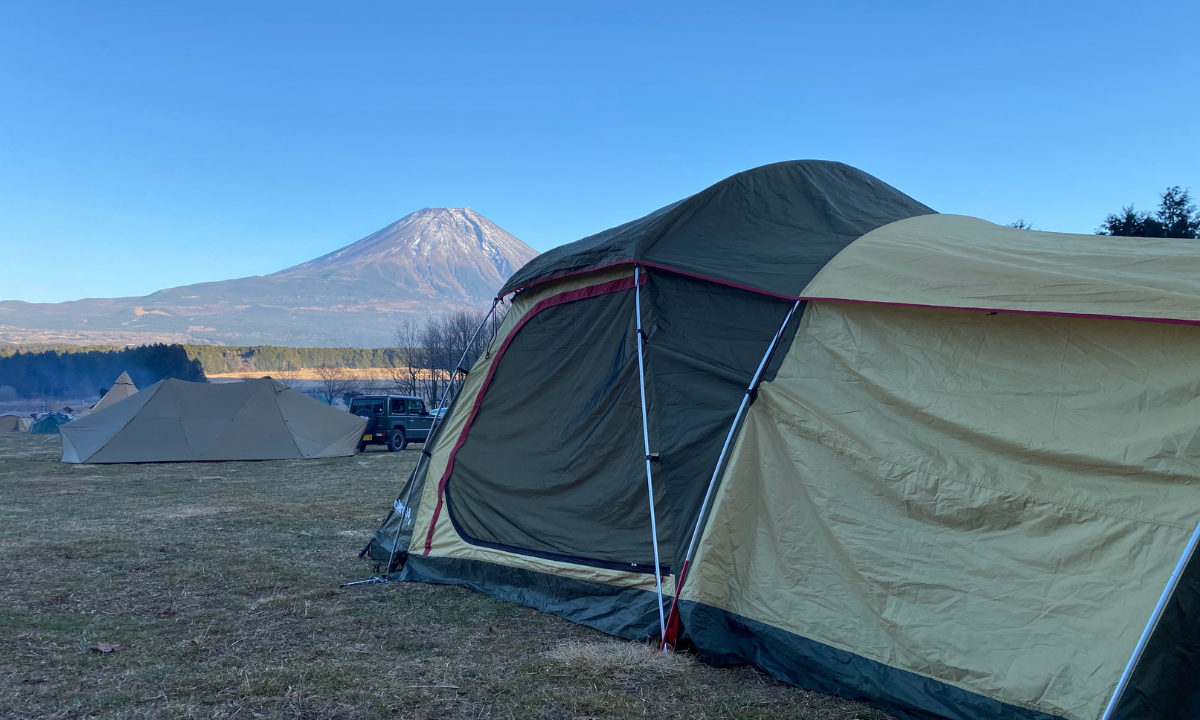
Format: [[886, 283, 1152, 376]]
[[0, 344, 206, 400]]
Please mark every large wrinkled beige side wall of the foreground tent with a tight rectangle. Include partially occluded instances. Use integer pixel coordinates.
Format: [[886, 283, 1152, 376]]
[[683, 302, 1200, 720]]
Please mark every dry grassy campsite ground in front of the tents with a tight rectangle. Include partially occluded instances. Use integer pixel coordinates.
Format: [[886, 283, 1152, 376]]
[[0, 433, 886, 720]]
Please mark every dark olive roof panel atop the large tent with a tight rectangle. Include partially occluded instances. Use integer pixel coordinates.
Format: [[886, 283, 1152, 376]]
[[500, 161, 934, 296]]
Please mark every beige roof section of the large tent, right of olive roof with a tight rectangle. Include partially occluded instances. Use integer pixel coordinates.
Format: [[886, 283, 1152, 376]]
[[803, 215, 1200, 323]]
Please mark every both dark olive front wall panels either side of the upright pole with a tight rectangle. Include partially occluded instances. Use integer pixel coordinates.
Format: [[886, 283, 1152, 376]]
[[445, 270, 791, 571]]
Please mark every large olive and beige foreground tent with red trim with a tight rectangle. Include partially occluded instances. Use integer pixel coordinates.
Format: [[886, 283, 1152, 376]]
[[368, 162, 1200, 720]]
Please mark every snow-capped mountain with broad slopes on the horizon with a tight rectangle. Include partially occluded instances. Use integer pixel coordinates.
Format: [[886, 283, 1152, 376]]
[[0, 208, 538, 347]]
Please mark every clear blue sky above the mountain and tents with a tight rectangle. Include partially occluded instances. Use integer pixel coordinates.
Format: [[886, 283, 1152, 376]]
[[0, 0, 1200, 301]]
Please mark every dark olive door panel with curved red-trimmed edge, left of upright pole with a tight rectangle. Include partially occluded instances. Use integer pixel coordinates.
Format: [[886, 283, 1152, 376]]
[[445, 289, 654, 570]]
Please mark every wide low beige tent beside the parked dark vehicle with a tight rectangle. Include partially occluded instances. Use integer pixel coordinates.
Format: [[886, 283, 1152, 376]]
[[62, 379, 366, 463]]
